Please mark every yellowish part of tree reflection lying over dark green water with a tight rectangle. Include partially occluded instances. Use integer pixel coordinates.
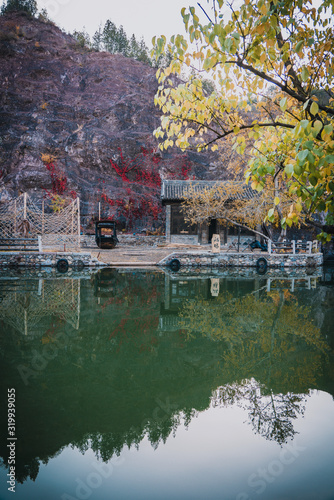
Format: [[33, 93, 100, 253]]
[[179, 290, 328, 392]]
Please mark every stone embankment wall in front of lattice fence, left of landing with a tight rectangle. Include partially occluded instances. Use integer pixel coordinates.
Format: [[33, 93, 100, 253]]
[[0, 252, 104, 268]]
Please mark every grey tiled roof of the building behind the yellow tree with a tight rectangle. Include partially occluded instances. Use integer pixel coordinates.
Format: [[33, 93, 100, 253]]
[[161, 180, 258, 202]]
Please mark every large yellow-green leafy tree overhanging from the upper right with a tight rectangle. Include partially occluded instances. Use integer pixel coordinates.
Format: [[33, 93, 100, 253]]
[[154, 0, 334, 240]]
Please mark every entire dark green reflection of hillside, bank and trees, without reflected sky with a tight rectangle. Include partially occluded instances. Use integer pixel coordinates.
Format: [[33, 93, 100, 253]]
[[0, 269, 334, 488]]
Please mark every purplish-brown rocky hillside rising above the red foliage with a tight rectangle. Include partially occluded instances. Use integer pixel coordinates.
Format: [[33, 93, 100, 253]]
[[0, 13, 224, 228]]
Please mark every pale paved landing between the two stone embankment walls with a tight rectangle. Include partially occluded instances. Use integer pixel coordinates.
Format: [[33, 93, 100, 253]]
[[85, 244, 210, 266]]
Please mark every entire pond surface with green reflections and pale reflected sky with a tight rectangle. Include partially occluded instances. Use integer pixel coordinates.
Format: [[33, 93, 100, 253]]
[[0, 269, 334, 500]]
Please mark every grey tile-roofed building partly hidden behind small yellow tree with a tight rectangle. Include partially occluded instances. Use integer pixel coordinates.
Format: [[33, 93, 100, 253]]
[[161, 180, 254, 244]]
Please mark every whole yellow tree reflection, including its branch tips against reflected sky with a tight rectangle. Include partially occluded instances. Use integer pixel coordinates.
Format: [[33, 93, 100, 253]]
[[180, 284, 328, 444]]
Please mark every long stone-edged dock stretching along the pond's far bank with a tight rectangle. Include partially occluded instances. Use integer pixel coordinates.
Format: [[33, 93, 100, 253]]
[[0, 244, 323, 269]]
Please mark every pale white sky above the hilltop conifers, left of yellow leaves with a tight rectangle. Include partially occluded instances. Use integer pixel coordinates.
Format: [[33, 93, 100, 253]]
[[37, 0, 196, 47]]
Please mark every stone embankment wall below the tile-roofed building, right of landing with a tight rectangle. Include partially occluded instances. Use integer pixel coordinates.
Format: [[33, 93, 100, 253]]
[[159, 251, 323, 267]]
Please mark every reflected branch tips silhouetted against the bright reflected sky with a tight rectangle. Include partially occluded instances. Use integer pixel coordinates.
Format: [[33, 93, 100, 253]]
[[213, 379, 305, 445]]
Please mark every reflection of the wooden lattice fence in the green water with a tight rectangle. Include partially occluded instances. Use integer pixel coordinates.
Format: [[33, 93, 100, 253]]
[[0, 277, 80, 335]]
